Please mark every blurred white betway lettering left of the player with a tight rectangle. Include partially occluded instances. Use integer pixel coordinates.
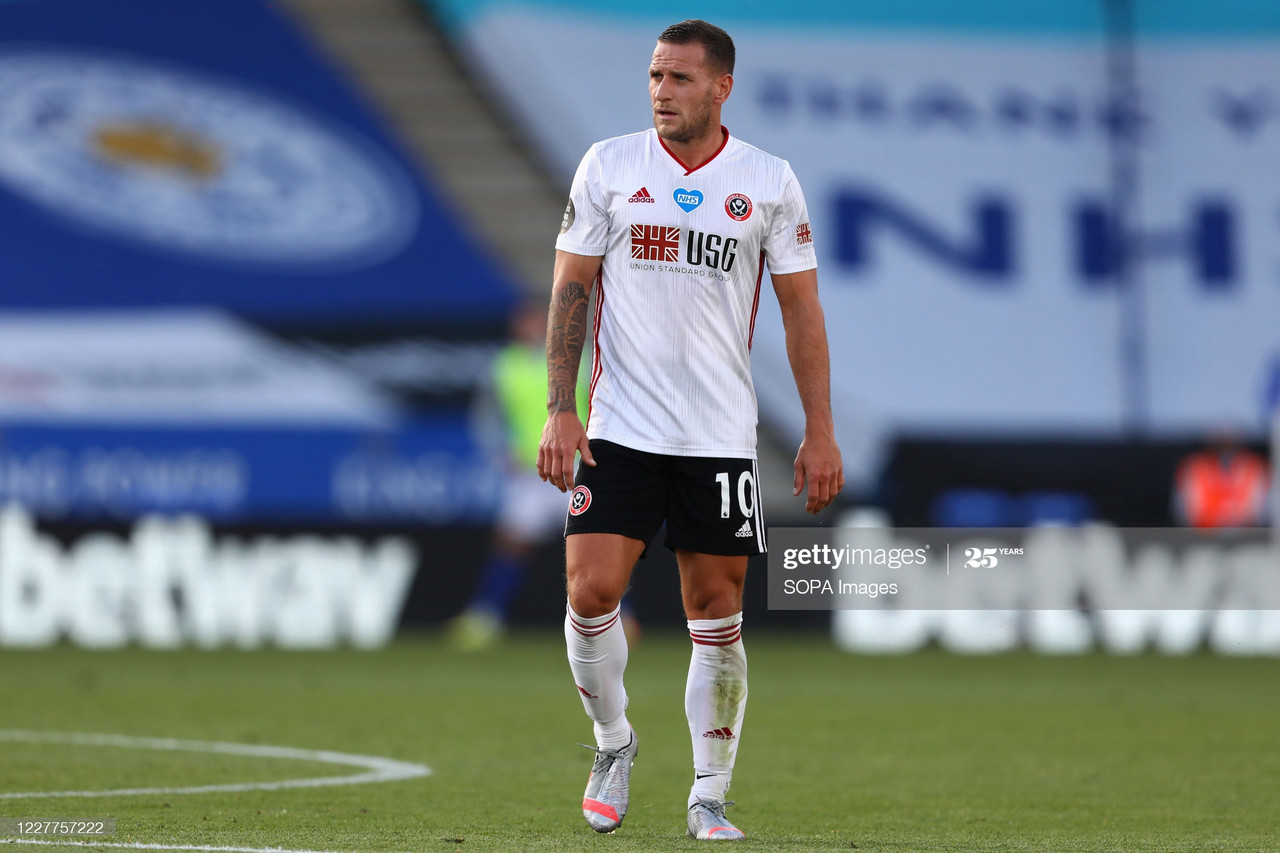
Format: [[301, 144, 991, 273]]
[[0, 506, 417, 648]]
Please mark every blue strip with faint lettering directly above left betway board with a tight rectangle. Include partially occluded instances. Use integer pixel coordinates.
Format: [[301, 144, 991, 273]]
[[0, 415, 503, 524]]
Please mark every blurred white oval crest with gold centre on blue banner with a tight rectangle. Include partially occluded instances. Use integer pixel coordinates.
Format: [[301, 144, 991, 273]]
[[0, 51, 417, 266]]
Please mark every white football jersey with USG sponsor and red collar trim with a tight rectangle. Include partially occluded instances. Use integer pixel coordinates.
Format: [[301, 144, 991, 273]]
[[556, 129, 818, 459]]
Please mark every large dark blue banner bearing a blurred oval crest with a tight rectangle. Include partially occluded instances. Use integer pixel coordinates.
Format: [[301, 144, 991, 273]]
[[0, 0, 517, 325]]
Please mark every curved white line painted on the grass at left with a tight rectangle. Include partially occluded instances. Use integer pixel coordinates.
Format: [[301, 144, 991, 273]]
[[0, 729, 431, 799]]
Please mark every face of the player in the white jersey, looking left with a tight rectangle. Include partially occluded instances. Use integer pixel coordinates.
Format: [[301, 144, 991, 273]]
[[649, 41, 733, 142]]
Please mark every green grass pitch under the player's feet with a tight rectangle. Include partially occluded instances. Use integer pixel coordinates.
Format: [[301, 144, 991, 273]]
[[0, 630, 1280, 853]]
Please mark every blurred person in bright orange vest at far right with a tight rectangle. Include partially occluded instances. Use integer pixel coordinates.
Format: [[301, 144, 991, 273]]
[[1174, 430, 1271, 528]]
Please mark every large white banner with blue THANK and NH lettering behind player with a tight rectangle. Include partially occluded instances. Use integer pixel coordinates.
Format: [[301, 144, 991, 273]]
[[433, 0, 1280, 438]]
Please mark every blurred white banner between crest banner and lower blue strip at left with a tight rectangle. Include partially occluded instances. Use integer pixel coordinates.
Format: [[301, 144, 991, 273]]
[[0, 309, 394, 429]]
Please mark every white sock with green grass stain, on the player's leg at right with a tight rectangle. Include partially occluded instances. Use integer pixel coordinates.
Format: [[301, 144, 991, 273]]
[[685, 612, 746, 806]]
